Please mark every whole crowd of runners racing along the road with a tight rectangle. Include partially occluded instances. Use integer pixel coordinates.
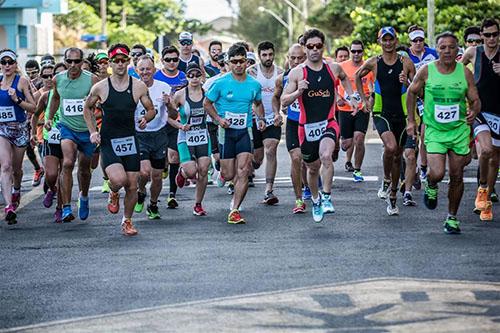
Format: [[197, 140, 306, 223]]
[[0, 19, 500, 236]]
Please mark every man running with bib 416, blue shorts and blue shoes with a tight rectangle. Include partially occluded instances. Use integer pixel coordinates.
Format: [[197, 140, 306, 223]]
[[45, 47, 99, 222]]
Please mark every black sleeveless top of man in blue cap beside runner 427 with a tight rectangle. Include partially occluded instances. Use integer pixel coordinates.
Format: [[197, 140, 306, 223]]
[[374, 56, 406, 121]]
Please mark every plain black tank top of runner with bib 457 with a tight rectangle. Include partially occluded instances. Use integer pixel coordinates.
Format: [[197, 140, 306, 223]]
[[101, 77, 137, 139]]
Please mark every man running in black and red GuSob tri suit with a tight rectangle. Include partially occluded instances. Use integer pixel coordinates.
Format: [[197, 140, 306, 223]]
[[281, 29, 362, 222]]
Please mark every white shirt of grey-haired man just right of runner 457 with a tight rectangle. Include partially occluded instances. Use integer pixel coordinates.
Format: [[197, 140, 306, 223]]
[[135, 80, 172, 132]]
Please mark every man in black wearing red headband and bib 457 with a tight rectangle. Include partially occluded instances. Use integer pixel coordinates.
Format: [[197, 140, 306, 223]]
[[84, 44, 156, 236]]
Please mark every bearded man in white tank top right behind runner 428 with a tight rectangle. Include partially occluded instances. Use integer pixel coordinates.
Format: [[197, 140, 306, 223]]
[[248, 41, 283, 205]]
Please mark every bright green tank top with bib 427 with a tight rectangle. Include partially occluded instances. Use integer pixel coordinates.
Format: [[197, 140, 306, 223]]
[[424, 63, 467, 131]]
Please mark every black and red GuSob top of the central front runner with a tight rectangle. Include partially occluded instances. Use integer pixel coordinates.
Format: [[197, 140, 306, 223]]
[[299, 63, 336, 125]]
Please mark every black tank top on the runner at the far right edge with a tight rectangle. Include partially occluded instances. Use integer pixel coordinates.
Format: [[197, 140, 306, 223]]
[[476, 46, 500, 116]]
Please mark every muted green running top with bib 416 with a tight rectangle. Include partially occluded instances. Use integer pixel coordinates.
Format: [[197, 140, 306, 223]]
[[56, 71, 92, 132]]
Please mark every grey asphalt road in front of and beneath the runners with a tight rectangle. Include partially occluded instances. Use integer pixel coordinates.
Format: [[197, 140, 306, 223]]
[[0, 139, 500, 332]]
